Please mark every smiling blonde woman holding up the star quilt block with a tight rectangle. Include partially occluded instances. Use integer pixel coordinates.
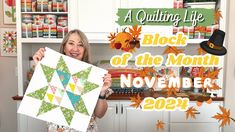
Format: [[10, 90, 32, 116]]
[[33, 29, 111, 132]]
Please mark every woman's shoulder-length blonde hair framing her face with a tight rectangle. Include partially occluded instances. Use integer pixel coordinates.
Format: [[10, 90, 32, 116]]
[[60, 29, 90, 63]]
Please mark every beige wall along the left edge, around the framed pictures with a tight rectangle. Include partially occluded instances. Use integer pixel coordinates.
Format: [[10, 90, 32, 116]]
[[0, 0, 17, 132]]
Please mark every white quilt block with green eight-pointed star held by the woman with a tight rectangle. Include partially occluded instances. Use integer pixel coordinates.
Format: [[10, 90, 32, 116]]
[[18, 48, 107, 131]]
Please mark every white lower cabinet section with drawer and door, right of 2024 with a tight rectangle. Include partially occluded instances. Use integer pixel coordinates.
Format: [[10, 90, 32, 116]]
[[170, 102, 222, 132]]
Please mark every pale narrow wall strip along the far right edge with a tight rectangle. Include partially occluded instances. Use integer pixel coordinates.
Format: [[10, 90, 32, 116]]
[[224, 0, 235, 132]]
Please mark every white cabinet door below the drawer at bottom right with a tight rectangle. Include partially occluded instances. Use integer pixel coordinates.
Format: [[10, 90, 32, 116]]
[[170, 123, 220, 132]]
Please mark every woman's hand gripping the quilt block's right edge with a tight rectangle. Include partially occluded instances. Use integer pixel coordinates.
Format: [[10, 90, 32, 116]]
[[100, 73, 112, 96]]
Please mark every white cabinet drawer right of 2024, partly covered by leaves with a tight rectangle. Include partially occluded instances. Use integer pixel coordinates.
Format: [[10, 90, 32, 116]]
[[170, 102, 222, 122]]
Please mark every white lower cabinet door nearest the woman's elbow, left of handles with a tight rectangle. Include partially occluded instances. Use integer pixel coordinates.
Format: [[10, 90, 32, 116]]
[[96, 101, 119, 132]]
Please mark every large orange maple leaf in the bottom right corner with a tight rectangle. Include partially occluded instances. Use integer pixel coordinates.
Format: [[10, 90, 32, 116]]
[[212, 106, 235, 127]]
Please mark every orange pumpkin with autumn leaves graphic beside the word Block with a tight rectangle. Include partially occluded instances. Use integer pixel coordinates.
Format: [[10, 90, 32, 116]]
[[108, 25, 142, 52]]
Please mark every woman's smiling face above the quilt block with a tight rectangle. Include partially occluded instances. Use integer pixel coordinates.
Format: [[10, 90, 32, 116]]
[[64, 33, 85, 60]]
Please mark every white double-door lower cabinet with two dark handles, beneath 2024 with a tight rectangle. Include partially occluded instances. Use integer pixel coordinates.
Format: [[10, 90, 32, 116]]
[[97, 101, 167, 132]]
